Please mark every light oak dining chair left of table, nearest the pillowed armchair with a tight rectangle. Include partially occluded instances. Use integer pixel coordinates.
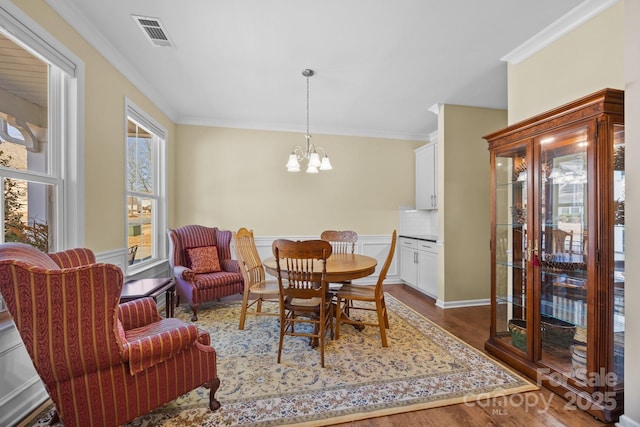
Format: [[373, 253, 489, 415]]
[[233, 227, 280, 330]]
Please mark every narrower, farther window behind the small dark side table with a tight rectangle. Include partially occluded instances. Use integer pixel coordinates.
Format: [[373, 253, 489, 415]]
[[125, 101, 166, 269]]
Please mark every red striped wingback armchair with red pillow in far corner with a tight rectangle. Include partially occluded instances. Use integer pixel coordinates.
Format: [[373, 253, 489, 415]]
[[167, 225, 244, 321]]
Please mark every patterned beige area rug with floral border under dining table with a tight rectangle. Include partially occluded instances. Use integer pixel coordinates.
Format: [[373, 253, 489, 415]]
[[28, 295, 537, 426]]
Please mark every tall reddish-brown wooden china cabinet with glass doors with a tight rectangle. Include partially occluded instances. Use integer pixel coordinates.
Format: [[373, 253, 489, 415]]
[[485, 89, 625, 421]]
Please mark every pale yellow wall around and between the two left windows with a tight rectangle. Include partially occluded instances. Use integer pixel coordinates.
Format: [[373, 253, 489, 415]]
[[13, 0, 175, 252]]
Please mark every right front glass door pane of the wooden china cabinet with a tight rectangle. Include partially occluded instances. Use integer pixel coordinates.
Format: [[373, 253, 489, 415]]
[[533, 126, 593, 381]]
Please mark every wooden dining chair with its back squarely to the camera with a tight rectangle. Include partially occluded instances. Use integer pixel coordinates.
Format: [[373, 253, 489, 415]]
[[272, 239, 333, 368]]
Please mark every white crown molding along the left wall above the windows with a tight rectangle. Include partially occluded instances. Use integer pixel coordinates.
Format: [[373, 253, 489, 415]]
[[45, 0, 177, 122]]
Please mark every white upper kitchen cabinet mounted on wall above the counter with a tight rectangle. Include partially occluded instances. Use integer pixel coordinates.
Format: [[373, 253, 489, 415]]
[[416, 143, 438, 210]]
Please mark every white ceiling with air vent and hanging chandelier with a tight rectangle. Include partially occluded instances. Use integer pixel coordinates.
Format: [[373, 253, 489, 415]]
[[46, 0, 611, 140]]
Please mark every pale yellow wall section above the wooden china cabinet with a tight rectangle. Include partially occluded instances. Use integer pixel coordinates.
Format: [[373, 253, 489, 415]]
[[508, 1, 624, 124]]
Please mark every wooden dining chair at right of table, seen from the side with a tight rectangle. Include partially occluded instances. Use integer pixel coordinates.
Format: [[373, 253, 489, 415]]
[[335, 230, 396, 347]]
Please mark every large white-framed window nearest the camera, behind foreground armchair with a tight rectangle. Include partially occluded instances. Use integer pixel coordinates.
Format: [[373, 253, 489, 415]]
[[0, 4, 84, 320]]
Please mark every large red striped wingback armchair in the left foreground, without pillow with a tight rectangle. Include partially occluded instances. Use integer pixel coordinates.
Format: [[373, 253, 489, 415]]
[[0, 243, 220, 427]]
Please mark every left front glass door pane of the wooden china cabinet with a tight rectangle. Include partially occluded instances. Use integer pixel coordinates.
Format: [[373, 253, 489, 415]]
[[494, 146, 530, 352]]
